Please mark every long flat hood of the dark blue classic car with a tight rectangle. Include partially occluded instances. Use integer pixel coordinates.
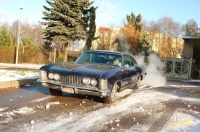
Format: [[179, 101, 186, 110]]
[[41, 63, 117, 78]]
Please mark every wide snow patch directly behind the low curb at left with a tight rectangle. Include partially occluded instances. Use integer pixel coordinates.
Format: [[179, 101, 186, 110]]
[[0, 70, 39, 82]]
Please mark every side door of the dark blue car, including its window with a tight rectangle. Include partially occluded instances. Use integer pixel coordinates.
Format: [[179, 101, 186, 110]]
[[124, 55, 137, 85]]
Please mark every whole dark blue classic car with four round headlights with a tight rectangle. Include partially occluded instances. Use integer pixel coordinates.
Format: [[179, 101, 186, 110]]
[[40, 51, 144, 103]]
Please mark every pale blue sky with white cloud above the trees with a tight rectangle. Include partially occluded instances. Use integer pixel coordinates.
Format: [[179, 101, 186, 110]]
[[0, 0, 200, 27]]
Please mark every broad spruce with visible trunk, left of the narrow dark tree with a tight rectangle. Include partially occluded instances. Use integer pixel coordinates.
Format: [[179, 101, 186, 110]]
[[43, 0, 91, 61]]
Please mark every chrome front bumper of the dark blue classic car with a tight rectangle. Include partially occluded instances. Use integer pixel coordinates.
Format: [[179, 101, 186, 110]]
[[38, 80, 111, 97]]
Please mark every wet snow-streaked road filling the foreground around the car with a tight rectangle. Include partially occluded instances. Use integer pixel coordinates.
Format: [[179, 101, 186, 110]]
[[0, 82, 200, 132]]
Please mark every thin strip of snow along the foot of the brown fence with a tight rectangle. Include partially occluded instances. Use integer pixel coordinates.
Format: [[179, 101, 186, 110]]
[[0, 63, 44, 69]]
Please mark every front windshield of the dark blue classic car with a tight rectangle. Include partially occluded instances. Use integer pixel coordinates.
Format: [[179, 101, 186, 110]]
[[76, 52, 122, 67]]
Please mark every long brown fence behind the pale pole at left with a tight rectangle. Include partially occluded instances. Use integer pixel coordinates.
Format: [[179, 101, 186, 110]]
[[0, 46, 80, 64]]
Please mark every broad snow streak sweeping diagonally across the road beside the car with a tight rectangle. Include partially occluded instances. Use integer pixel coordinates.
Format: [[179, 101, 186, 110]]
[[28, 86, 198, 131]]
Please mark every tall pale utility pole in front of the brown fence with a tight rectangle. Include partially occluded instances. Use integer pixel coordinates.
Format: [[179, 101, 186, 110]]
[[15, 5, 23, 64]]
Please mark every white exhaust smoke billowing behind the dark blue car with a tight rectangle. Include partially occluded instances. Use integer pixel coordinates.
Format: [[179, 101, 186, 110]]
[[119, 34, 167, 87]]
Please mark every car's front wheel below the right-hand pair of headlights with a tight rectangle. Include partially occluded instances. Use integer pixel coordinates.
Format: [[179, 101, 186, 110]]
[[105, 83, 119, 104]]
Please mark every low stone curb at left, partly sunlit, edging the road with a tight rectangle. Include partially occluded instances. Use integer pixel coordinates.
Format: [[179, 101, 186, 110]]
[[0, 78, 38, 89]]
